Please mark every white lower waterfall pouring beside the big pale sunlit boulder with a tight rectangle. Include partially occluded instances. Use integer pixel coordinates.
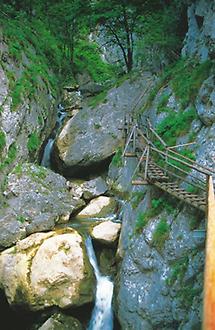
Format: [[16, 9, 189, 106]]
[[85, 237, 113, 330]]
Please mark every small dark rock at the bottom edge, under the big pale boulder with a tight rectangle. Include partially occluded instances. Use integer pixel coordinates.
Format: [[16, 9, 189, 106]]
[[38, 313, 84, 330]]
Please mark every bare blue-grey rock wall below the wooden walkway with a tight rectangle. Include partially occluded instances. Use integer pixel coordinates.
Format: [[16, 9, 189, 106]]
[[115, 193, 205, 330]]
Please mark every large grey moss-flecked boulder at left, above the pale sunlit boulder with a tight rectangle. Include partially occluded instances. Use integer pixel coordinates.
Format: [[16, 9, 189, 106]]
[[0, 164, 84, 248]]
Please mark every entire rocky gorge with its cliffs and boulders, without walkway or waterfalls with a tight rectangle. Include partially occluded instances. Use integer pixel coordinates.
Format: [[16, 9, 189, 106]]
[[0, 0, 215, 330]]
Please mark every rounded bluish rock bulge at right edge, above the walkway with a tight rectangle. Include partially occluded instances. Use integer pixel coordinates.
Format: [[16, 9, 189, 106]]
[[196, 76, 215, 126]]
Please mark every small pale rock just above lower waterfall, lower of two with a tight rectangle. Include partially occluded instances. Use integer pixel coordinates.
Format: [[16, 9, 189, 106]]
[[91, 221, 121, 245]]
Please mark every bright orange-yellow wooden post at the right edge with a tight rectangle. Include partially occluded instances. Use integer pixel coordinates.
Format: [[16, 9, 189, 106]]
[[203, 176, 215, 330]]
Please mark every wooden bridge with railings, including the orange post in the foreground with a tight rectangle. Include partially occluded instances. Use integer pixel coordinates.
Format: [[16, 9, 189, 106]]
[[122, 116, 215, 330]]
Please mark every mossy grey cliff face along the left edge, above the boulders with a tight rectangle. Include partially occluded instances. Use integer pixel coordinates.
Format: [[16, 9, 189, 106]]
[[0, 27, 56, 189]]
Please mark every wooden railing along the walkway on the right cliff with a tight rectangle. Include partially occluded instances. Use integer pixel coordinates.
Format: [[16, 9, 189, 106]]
[[123, 117, 215, 204]]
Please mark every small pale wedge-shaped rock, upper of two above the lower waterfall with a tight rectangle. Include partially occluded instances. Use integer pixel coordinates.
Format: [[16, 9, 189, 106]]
[[77, 196, 117, 218]]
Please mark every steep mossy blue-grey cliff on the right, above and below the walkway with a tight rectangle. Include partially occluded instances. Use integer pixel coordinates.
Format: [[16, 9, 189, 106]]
[[112, 1, 215, 330]]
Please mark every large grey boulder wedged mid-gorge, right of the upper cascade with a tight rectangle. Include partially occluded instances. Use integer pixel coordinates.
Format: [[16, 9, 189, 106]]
[[54, 74, 151, 177]]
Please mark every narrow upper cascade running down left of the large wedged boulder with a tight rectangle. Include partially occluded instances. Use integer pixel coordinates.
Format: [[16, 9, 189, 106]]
[[41, 104, 66, 168]]
